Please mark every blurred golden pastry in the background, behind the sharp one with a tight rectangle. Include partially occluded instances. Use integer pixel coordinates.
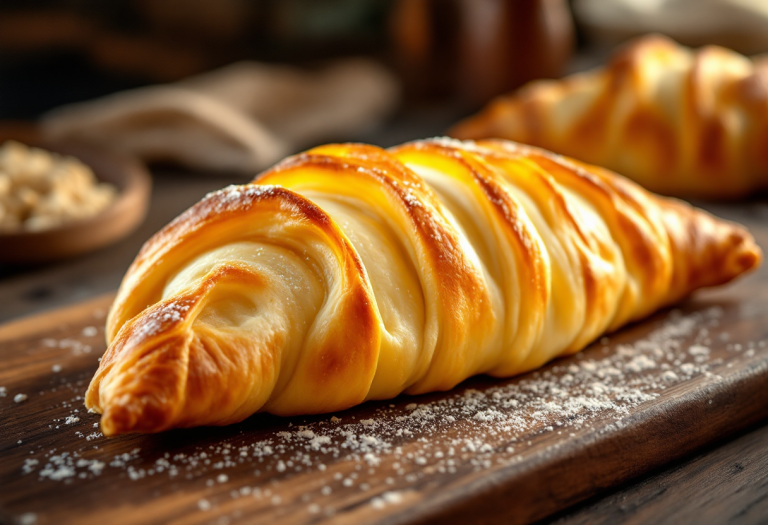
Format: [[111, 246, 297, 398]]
[[449, 35, 768, 199]]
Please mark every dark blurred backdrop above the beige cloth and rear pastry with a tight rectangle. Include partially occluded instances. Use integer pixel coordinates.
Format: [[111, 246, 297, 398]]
[[0, 0, 768, 122]]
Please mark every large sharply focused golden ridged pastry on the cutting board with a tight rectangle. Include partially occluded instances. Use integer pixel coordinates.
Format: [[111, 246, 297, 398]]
[[86, 139, 761, 435]]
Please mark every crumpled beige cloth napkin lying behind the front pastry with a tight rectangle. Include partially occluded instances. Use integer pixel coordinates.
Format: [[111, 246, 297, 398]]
[[41, 59, 399, 173]]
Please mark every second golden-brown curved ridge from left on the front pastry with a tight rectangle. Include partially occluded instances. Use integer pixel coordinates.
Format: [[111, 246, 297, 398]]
[[257, 144, 493, 393]]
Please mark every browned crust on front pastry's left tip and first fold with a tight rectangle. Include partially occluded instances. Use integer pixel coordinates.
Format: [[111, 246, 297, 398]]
[[86, 186, 378, 434]]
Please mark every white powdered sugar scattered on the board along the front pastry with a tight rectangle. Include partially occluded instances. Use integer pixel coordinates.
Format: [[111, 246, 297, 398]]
[[9, 303, 766, 519]]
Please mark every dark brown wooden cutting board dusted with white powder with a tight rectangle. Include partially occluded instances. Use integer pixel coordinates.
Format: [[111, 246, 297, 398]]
[[0, 213, 768, 524]]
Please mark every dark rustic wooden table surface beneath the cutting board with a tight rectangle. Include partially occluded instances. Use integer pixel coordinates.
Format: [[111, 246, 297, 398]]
[[0, 109, 768, 525]]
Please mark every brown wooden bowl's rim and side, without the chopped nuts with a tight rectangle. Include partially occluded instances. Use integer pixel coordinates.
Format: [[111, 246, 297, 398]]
[[0, 133, 152, 264]]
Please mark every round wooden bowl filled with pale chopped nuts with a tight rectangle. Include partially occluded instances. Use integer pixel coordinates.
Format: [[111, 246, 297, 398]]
[[0, 140, 150, 263]]
